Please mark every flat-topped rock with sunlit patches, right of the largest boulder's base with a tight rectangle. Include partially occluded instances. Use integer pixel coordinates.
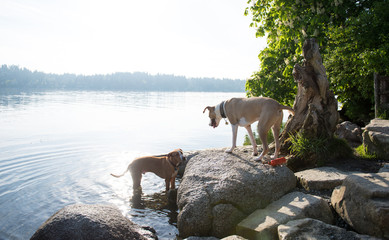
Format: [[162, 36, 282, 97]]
[[237, 192, 334, 240]]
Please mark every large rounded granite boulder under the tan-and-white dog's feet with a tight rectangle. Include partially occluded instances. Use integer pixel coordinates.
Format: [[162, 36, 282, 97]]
[[177, 147, 296, 238]]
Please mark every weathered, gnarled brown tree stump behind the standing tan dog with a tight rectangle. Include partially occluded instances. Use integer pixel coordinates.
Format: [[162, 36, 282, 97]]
[[280, 38, 339, 169]]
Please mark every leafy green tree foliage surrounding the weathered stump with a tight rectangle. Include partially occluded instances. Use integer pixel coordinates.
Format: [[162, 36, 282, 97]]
[[245, 0, 389, 123]]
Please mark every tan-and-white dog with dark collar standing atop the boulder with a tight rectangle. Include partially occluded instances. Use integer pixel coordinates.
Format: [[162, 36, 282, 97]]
[[203, 97, 294, 161]]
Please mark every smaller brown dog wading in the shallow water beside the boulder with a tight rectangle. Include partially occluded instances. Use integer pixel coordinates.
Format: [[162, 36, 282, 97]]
[[111, 149, 185, 191]]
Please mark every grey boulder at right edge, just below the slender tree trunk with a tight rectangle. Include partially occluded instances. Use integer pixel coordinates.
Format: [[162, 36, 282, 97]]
[[363, 118, 389, 159]]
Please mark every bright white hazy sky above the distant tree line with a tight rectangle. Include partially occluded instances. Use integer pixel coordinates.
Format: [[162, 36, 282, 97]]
[[0, 0, 266, 79]]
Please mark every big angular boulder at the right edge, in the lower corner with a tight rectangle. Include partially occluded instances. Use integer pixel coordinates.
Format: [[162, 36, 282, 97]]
[[331, 172, 389, 238]]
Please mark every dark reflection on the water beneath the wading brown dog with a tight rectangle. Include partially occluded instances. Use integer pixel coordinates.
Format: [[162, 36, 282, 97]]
[[130, 189, 178, 226]]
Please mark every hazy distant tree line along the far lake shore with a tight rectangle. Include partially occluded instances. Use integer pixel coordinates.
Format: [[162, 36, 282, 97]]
[[0, 65, 245, 92]]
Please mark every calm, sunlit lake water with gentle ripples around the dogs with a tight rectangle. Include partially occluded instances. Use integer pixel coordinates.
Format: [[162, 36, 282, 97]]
[[0, 92, 246, 239]]
